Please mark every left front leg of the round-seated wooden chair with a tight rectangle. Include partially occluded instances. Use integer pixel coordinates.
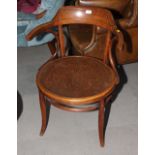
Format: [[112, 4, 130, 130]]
[[39, 91, 47, 136]]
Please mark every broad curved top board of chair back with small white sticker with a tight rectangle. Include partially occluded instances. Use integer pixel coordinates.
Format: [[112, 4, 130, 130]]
[[52, 6, 117, 31]]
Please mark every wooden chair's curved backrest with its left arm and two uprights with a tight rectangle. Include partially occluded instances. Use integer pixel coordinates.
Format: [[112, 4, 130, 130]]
[[27, 6, 117, 60]]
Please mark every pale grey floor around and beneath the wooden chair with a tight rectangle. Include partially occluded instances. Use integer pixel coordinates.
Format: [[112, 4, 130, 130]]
[[17, 46, 138, 155]]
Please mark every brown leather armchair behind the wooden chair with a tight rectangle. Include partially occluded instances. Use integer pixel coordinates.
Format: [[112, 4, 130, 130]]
[[69, 0, 138, 64]]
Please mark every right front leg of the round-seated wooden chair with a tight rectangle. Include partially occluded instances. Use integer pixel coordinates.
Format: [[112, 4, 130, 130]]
[[98, 99, 105, 146]]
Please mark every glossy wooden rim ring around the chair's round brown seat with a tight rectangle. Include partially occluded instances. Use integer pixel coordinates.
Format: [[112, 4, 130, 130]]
[[36, 56, 116, 106]]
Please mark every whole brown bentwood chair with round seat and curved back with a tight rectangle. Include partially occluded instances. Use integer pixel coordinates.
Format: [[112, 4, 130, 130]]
[[27, 6, 121, 146]]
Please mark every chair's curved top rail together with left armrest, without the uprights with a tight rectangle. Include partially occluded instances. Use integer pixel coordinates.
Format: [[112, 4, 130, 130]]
[[26, 6, 117, 40]]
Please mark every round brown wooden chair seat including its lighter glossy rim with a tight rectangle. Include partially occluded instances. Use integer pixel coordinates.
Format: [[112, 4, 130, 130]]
[[36, 56, 116, 105]]
